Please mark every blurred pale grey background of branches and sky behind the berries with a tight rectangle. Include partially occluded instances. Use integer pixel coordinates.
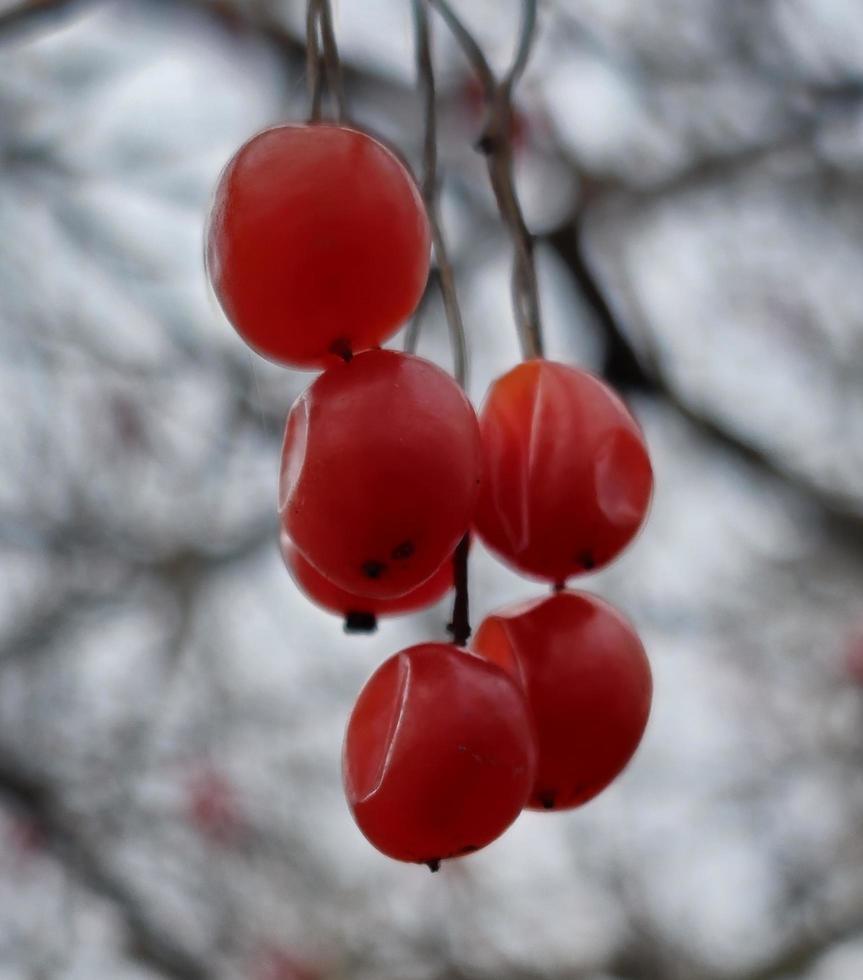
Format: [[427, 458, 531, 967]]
[[0, 0, 863, 980]]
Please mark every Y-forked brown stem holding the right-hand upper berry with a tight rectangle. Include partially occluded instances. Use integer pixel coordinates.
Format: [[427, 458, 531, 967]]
[[429, 0, 543, 358]]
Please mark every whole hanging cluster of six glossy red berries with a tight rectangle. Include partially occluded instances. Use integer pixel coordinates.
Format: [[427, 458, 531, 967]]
[[207, 124, 652, 868]]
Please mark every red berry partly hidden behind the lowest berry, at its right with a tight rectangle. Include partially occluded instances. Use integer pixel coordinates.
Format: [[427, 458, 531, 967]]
[[473, 592, 653, 810]]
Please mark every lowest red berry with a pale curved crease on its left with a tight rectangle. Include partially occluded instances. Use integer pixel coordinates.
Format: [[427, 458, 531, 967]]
[[343, 643, 536, 865]]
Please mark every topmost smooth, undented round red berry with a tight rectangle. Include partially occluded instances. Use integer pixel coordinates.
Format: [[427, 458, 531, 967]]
[[207, 124, 430, 367]]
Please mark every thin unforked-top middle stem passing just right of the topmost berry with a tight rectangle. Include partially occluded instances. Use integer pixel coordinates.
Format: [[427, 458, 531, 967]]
[[416, 0, 467, 388]]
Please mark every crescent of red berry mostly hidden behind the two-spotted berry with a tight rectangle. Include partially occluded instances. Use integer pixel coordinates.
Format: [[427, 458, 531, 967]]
[[279, 528, 453, 616]]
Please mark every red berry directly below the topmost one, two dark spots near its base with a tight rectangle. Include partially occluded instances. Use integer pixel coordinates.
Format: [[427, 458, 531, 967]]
[[279, 350, 482, 599]]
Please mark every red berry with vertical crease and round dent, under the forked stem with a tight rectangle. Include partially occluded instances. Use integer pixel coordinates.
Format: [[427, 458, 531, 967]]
[[476, 360, 653, 583]]
